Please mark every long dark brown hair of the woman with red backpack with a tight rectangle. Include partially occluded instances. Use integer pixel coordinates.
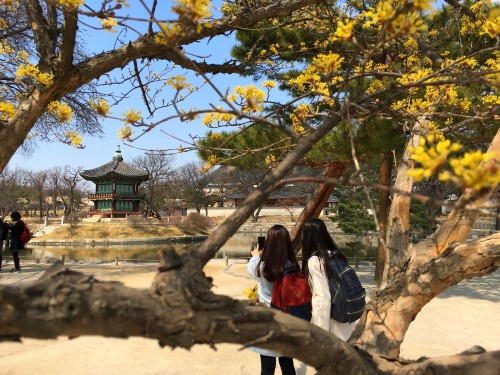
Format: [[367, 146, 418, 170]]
[[257, 225, 299, 282]]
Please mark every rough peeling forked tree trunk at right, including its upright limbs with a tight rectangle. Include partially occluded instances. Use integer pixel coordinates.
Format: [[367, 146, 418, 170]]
[[350, 129, 500, 358]]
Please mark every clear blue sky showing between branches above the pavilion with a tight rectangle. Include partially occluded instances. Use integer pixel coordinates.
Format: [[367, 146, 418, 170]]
[[8, 2, 253, 171]]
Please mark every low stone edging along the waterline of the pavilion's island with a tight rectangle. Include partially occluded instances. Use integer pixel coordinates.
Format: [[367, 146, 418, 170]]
[[27, 236, 208, 247]]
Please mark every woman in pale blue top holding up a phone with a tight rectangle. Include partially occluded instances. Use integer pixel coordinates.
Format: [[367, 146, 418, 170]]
[[247, 225, 300, 375]]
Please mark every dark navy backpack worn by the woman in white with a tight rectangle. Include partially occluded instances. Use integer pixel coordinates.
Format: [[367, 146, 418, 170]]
[[328, 251, 366, 323]]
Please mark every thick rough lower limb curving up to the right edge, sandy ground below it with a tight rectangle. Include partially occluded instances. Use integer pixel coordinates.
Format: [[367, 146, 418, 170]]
[[349, 233, 500, 358]]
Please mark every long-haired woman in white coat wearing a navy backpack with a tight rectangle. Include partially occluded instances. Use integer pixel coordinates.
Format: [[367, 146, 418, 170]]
[[302, 219, 356, 341]]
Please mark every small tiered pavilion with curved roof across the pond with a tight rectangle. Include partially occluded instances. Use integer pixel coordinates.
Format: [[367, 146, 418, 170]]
[[80, 146, 149, 218]]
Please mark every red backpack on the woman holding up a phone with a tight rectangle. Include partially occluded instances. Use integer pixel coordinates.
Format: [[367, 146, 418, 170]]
[[271, 269, 312, 320]]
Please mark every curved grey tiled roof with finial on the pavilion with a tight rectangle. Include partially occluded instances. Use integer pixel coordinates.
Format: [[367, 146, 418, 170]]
[[80, 147, 149, 181]]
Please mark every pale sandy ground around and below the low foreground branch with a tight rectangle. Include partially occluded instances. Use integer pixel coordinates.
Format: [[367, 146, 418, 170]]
[[0, 259, 500, 375]]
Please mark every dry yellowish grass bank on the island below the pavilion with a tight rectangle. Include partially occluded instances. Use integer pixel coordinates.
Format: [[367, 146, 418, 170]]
[[40, 223, 189, 240]]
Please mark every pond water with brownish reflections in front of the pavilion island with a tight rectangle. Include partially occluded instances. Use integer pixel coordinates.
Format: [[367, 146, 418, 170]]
[[13, 233, 257, 261]]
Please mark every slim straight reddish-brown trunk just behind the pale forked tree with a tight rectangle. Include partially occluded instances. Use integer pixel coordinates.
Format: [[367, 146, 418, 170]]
[[375, 151, 393, 286]]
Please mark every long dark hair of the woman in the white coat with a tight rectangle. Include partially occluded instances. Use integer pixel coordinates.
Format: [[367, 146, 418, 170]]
[[302, 219, 347, 280]]
